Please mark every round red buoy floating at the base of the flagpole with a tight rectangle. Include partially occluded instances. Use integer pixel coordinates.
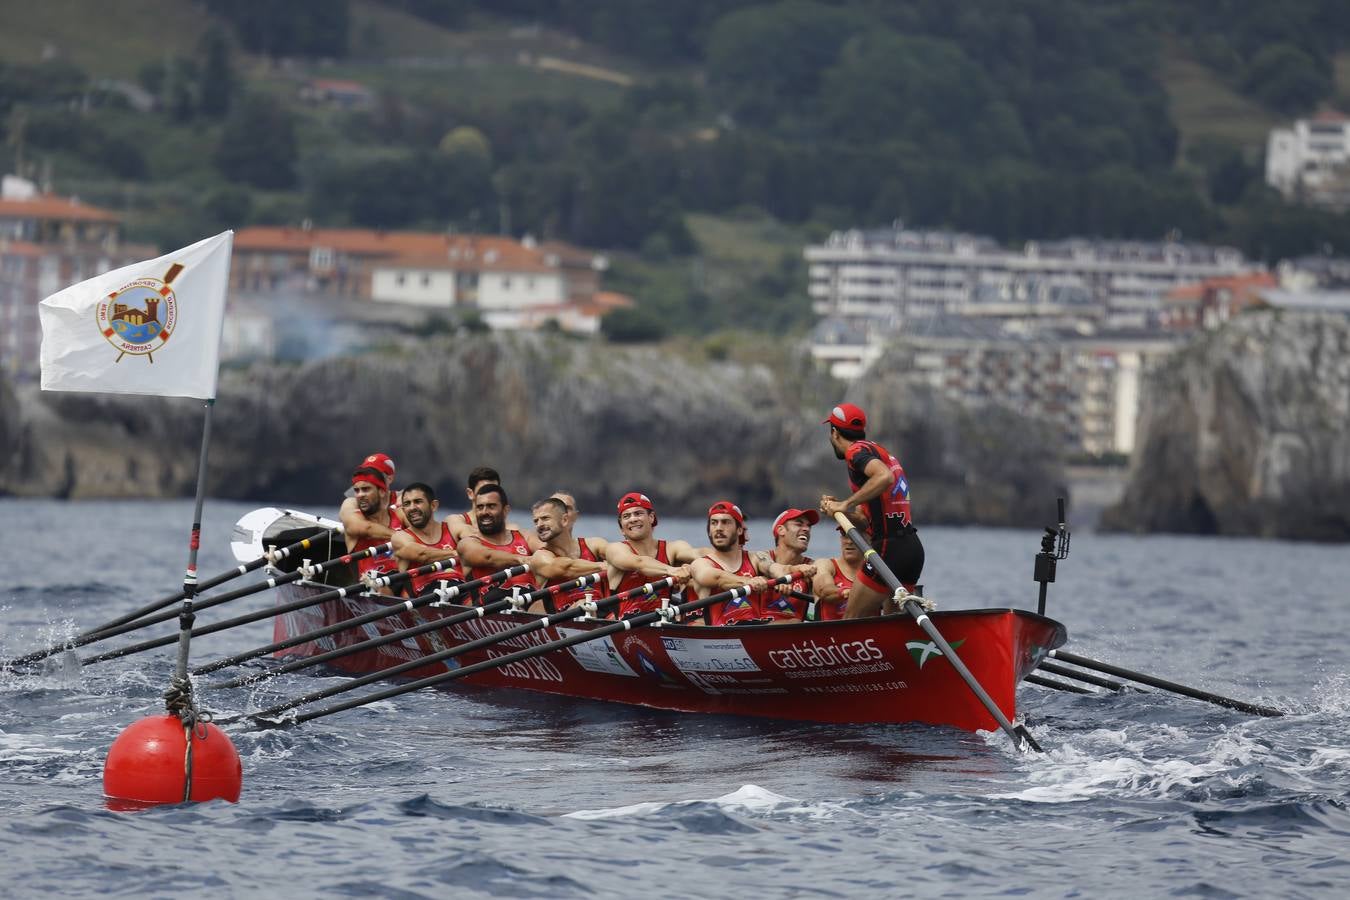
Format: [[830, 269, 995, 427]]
[[103, 715, 243, 808]]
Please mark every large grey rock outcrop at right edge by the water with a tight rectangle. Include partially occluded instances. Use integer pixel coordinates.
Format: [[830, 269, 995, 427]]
[[1103, 313, 1350, 541]]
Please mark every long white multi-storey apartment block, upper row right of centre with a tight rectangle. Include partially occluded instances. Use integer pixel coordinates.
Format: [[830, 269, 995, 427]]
[[805, 223, 1261, 334]]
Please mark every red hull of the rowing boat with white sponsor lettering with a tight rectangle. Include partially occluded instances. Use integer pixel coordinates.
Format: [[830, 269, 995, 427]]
[[275, 584, 1067, 731]]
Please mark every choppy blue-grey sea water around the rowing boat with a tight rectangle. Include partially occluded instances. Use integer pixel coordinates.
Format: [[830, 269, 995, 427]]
[[0, 499, 1350, 897]]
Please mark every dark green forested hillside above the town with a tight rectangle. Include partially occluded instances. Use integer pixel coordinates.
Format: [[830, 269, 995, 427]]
[[0, 0, 1350, 331]]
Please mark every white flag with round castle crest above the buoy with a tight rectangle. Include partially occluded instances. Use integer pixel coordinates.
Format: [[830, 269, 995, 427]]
[[38, 231, 235, 399]]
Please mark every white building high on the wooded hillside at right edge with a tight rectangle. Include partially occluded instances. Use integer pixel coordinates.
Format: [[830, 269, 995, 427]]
[[1266, 112, 1350, 209]]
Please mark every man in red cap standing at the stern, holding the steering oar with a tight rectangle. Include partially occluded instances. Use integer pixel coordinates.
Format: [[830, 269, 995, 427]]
[[821, 403, 923, 619]]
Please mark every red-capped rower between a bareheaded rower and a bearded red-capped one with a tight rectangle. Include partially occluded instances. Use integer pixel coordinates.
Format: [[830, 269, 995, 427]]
[[605, 491, 703, 618]]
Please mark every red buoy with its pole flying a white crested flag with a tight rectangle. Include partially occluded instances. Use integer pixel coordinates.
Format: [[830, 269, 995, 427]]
[[38, 231, 243, 808]]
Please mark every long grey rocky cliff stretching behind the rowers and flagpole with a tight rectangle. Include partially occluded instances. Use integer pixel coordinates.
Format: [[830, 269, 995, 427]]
[[0, 335, 1062, 528]]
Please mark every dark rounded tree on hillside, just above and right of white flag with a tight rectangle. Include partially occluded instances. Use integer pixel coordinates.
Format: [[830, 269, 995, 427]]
[[215, 94, 300, 189]]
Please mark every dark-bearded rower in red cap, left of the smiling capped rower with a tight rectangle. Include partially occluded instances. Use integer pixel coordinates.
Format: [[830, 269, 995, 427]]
[[690, 501, 815, 625]]
